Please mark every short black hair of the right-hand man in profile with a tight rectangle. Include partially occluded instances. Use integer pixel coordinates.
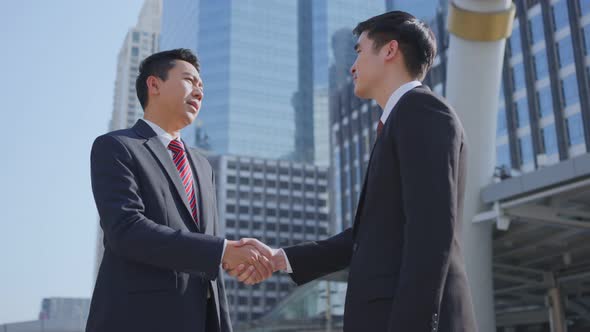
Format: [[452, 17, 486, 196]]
[[353, 11, 436, 79]]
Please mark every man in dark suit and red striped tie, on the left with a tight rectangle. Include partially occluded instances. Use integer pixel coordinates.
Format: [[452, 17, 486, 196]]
[[86, 49, 272, 332]]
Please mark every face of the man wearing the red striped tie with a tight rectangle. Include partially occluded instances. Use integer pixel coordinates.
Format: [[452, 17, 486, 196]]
[[160, 60, 203, 128]]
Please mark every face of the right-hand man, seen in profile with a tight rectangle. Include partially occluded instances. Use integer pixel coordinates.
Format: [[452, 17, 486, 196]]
[[350, 31, 385, 99]]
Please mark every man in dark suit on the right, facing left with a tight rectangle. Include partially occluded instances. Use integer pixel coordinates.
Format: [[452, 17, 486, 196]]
[[229, 11, 477, 332]]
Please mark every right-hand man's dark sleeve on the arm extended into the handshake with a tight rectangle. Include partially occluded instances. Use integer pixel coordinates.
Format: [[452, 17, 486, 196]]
[[284, 228, 353, 285]]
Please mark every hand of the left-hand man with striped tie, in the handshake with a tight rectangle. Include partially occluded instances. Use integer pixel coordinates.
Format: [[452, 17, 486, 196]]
[[222, 240, 275, 285]]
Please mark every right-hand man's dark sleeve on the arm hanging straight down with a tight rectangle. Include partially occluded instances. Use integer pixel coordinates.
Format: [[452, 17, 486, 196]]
[[389, 102, 462, 331]]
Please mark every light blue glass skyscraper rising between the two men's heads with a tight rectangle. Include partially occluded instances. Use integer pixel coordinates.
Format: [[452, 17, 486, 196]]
[[161, 0, 298, 158]]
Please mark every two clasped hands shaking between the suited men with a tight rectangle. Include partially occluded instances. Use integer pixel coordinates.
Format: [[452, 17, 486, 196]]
[[221, 238, 287, 285]]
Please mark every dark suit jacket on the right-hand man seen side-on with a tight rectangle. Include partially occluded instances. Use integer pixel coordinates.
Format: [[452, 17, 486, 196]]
[[285, 87, 476, 332]]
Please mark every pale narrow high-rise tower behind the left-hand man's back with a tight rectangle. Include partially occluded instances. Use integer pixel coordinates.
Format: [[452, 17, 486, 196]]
[[95, 0, 162, 273]]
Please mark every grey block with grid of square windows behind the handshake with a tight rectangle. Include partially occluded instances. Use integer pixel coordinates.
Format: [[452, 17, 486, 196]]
[[209, 155, 332, 324]]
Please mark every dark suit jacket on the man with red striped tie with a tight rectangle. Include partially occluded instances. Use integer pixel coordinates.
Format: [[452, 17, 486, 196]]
[[86, 120, 231, 332]]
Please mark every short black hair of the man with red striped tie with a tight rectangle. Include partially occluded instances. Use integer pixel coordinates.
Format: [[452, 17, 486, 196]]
[[135, 48, 199, 110]]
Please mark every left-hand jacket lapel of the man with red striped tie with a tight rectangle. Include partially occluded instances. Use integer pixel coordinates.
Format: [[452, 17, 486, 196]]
[[133, 120, 199, 231]]
